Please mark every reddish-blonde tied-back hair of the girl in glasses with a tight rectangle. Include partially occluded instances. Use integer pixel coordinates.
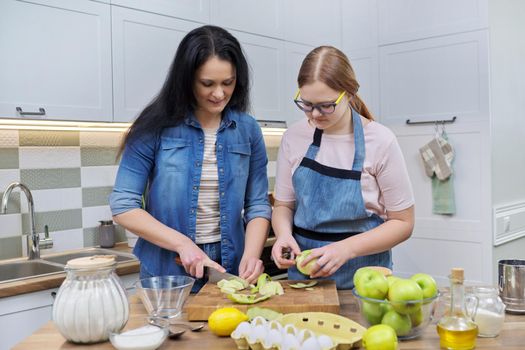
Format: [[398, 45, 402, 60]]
[[297, 46, 374, 120]]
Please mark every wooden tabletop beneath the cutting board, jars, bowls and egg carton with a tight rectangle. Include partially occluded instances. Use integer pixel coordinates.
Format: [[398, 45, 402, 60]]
[[14, 291, 525, 350]]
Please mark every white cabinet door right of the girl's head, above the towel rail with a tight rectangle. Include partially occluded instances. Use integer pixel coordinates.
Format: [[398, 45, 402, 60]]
[[379, 30, 489, 124]]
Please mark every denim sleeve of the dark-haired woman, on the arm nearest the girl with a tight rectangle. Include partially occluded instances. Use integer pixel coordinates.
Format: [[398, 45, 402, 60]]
[[244, 125, 272, 223]]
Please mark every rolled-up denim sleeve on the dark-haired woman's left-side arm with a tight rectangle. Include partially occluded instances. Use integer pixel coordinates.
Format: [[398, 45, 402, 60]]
[[109, 137, 156, 215]]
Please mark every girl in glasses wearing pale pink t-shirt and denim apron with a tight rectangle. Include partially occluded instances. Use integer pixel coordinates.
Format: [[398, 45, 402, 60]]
[[272, 46, 414, 289]]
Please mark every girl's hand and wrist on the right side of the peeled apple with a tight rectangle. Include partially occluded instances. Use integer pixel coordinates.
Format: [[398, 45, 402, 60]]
[[301, 241, 353, 278]]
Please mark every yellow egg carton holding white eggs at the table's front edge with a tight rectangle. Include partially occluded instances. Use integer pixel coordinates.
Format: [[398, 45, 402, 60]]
[[231, 312, 366, 350]]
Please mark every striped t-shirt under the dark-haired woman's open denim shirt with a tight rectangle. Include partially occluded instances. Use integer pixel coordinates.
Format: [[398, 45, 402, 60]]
[[195, 128, 221, 244]]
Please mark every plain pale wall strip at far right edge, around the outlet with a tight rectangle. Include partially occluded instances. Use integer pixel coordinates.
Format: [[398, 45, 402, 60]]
[[489, 0, 525, 274]]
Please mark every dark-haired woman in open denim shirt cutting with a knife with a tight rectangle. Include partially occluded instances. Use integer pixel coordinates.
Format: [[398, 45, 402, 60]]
[[110, 26, 271, 291]]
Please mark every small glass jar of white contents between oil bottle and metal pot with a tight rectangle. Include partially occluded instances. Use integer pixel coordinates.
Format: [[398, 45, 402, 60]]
[[472, 287, 505, 337]]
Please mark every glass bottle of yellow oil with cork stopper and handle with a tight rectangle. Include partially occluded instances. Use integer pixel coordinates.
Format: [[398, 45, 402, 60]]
[[437, 268, 478, 350]]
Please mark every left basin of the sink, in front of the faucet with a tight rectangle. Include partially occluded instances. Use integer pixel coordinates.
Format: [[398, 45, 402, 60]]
[[0, 260, 64, 282]]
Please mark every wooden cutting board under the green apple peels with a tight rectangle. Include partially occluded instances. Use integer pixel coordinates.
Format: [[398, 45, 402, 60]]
[[185, 280, 339, 321]]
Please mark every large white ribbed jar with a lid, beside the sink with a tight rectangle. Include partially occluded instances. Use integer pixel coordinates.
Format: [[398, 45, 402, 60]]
[[53, 255, 129, 343]]
